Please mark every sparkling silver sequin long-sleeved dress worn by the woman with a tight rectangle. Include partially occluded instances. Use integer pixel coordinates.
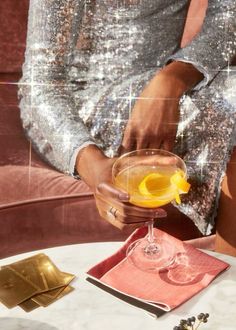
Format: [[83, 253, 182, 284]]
[[19, 0, 236, 234]]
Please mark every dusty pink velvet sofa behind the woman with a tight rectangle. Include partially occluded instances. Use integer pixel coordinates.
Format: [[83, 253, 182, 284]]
[[0, 0, 207, 258]]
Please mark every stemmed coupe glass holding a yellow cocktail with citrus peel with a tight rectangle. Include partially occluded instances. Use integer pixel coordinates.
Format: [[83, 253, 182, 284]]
[[112, 149, 190, 271]]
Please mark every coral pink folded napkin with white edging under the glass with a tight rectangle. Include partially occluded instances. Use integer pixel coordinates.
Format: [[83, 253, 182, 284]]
[[87, 227, 229, 311]]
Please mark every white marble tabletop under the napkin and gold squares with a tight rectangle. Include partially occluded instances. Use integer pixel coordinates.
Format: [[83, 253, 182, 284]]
[[0, 243, 236, 330]]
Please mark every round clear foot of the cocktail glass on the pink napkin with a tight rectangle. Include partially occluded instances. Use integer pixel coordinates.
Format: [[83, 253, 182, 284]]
[[126, 238, 175, 272]]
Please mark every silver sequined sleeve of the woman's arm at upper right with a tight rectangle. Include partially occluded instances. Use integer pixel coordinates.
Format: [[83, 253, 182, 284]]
[[168, 0, 236, 88]]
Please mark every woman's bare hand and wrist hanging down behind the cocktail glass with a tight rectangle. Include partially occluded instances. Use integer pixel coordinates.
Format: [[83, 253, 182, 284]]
[[120, 62, 203, 153]]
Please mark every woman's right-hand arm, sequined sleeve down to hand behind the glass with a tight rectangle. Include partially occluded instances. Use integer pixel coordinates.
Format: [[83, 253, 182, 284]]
[[121, 0, 236, 153]]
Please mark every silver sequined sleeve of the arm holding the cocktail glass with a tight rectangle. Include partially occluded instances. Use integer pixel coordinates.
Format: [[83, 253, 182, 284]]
[[19, 0, 95, 173]]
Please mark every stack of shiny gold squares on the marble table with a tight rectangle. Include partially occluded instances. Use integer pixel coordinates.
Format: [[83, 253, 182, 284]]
[[0, 253, 75, 312]]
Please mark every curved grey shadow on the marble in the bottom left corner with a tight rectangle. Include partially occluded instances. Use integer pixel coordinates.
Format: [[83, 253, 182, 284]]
[[0, 317, 58, 330]]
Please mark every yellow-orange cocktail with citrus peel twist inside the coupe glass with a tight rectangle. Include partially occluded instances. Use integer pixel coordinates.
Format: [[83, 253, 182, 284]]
[[115, 165, 190, 208]]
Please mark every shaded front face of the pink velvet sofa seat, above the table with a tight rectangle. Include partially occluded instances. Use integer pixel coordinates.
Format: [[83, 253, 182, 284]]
[[0, 195, 127, 259]]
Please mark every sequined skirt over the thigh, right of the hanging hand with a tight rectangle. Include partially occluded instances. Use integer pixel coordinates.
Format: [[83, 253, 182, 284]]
[[172, 68, 236, 234]]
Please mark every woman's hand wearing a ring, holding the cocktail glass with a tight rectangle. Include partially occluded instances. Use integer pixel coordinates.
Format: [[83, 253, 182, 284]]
[[76, 145, 166, 230]]
